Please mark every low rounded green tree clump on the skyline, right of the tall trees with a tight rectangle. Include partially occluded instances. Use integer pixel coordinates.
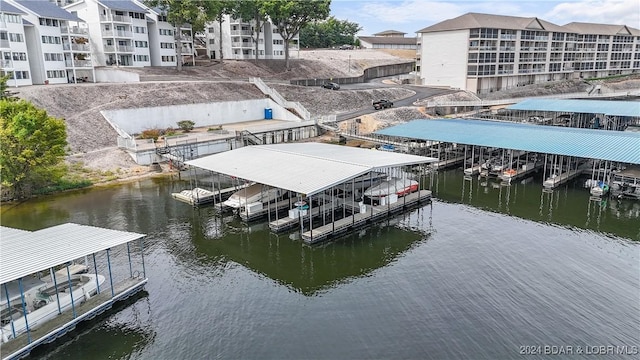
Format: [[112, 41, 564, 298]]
[[300, 16, 362, 48]]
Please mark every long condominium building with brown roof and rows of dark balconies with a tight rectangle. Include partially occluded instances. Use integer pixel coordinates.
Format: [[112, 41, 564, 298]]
[[416, 13, 640, 94]]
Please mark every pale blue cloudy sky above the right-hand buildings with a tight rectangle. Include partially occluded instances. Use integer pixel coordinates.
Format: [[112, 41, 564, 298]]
[[331, 0, 640, 37]]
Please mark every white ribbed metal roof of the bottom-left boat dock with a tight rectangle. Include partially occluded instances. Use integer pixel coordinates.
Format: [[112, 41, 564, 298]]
[[0, 223, 145, 284]]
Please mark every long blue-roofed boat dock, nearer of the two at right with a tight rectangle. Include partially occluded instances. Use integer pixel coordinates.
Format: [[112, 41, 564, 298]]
[[376, 118, 640, 188]]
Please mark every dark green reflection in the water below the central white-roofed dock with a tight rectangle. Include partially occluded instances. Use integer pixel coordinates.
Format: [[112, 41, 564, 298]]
[[185, 205, 431, 295]]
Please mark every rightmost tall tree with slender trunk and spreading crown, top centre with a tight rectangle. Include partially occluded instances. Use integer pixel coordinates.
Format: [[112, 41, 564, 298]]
[[263, 0, 331, 70]]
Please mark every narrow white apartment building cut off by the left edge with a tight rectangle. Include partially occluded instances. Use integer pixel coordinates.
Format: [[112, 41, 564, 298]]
[[0, 0, 32, 86]]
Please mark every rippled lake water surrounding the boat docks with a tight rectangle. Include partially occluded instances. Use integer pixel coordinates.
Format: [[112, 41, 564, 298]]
[[2, 170, 640, 359]]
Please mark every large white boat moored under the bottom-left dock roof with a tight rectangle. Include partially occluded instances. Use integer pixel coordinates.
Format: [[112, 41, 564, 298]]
[[0, 265, 105, 343]]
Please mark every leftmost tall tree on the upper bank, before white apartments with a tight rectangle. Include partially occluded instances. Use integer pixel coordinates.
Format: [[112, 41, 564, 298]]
[[144, 0, 207, 71]]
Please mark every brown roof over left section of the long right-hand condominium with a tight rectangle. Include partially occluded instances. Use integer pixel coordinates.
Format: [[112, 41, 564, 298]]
[[417, 13, 567, 33]]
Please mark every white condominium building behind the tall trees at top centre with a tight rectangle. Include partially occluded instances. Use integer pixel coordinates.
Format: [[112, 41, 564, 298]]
[[205, 15, 299, 60]]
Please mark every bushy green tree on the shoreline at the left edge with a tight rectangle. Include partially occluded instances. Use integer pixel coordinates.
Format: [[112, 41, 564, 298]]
[[0, 99, 67, 199]]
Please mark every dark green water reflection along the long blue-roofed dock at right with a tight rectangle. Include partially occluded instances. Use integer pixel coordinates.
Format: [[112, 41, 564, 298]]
[[427, 169, 640, 240]]
